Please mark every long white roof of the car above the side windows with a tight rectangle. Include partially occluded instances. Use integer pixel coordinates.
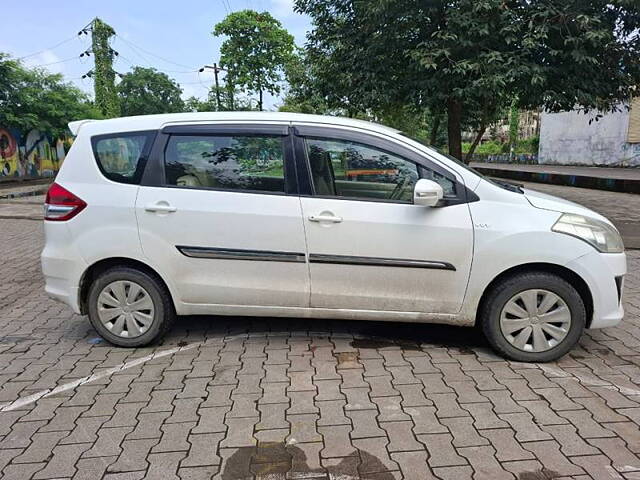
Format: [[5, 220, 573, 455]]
[[69, 112, 398, 135]]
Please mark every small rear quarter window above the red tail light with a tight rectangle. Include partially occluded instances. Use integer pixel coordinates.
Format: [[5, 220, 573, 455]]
[[92, 132, 154, 184]]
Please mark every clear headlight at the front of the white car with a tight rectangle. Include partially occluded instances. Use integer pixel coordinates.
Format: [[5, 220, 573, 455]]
[[551, 213, 624, 253]]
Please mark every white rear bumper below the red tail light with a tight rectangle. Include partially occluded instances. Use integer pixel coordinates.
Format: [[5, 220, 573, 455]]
[[40, 221, 87, 314]]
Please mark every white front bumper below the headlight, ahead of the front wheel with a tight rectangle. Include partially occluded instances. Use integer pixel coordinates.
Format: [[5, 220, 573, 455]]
[[567, 251, 627, 328]]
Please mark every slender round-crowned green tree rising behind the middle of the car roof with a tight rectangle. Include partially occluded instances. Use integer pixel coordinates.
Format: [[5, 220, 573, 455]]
[[213, 10, 294, 110]]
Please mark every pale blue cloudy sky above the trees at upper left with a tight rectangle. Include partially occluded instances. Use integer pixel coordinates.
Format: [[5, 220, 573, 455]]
[[0, 0, 311, 109]]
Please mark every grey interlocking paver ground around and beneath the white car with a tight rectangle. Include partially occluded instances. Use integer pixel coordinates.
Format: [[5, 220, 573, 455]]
[[0, 184, 640, 480]]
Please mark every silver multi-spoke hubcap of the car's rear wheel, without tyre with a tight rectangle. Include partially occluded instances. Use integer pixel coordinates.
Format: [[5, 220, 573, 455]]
[[98, 280, 154, 338]]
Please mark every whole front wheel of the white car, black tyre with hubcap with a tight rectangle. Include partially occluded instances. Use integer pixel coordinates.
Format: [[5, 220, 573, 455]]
[[480, 272, 587, 362]]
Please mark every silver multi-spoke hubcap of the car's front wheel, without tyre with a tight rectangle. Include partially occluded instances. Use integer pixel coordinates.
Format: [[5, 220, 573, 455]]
[[500, 289, 571, 352]]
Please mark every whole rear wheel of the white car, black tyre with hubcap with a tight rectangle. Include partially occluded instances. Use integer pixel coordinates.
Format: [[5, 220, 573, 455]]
[[88, 267, 175, 347]]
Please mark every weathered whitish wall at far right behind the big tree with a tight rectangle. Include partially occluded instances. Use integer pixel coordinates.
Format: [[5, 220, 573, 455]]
[[538, 108, 640, 166]]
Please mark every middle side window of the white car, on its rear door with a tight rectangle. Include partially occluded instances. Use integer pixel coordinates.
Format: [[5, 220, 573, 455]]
[[165, 135, 285, 192]]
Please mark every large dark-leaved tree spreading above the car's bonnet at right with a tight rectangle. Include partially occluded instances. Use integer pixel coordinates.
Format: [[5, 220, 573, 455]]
[[296, 0, 640, 158]]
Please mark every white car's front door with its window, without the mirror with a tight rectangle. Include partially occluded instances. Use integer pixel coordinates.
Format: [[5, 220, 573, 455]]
[[296, 127, 473, 314]]
